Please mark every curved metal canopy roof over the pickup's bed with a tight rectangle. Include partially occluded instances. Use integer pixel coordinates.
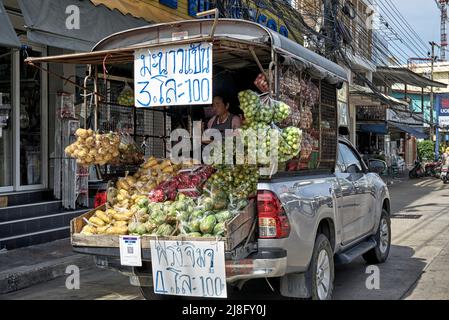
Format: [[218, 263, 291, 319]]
[[23, 19, 348, 83]]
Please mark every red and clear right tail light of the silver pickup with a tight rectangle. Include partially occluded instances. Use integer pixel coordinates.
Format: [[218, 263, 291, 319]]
[[257, 191, 290, 239]]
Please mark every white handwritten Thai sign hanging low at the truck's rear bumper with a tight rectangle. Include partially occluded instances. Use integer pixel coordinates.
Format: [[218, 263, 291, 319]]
[[151, 241, 227, 298]]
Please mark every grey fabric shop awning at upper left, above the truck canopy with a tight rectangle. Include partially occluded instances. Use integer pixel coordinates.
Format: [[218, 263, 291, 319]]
[[19, 0, 148, 51]]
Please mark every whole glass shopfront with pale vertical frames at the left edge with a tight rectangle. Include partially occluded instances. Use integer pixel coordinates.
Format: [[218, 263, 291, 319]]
[[0, 40, 48, 192]]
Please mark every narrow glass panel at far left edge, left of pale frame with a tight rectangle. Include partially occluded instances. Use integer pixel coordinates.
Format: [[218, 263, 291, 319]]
[[0, 48, 13, 188]]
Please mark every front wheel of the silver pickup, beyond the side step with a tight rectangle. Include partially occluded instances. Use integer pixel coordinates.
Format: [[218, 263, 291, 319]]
[[363, 210, 391, 264]]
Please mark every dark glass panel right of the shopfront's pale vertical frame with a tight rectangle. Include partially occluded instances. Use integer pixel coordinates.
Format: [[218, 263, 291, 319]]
[[20, 50, 42, 186]]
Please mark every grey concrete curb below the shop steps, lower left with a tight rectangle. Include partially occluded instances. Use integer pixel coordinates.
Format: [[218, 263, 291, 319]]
[[0, 255, 95, 294]]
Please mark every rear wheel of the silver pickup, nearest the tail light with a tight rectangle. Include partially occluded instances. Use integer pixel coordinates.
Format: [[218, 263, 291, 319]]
[[309, 234, 335, 300]]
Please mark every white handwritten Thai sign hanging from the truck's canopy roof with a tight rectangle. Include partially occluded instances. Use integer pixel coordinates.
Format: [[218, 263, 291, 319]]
[[134, 43, 213, 108]]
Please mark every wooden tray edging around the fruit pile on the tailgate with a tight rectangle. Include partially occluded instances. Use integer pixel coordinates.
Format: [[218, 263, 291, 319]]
[[70, 200, 256, 251]]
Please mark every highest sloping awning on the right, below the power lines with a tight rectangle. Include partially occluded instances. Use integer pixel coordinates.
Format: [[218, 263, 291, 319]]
[[373, 67, 447, 88]]
